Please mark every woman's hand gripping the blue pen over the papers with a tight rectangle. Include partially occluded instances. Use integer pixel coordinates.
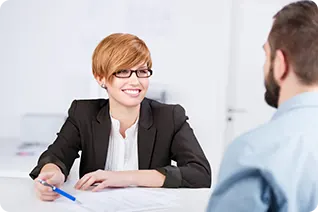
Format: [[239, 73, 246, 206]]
[[35, 170, 65, 201]]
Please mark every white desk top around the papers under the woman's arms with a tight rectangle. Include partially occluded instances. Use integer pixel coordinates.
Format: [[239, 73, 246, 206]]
[[0, 177, 211, 212]]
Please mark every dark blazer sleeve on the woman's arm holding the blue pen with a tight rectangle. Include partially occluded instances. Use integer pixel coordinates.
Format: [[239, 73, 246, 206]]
[[29, 100, 81, 180]]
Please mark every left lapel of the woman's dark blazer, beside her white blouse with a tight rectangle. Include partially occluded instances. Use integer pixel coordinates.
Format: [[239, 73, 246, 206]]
[[92, 101, 111, 169]]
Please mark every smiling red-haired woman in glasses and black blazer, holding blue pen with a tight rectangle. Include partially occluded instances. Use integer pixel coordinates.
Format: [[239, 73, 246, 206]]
[[30, 33, 211, 201]]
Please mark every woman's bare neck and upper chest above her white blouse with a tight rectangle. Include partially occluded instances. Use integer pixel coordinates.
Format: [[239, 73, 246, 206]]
[[109, 99, 140, 132]]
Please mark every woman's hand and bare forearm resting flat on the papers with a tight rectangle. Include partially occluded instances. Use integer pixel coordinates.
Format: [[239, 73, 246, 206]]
[[75, 170, 133, 191]]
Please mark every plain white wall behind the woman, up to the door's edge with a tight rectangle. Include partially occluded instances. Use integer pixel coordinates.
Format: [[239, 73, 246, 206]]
[[0, 0, 231, 180]]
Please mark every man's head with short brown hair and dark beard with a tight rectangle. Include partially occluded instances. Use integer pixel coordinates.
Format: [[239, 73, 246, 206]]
[[264, 1, 318, 108]]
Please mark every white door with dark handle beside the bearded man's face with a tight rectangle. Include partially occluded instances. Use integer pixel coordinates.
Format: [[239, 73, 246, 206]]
[[225, 0, 286, 147]]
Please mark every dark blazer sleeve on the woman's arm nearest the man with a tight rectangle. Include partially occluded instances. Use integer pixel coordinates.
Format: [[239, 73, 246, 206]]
[[157, 105, 211, 188]]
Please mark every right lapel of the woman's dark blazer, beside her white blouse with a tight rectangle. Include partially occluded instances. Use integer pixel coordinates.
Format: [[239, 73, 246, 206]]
[[138, 99, 157, 169]]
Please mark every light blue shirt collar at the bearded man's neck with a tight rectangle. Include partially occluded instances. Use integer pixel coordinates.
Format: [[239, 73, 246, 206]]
[[273, 92, 318, 119]]
